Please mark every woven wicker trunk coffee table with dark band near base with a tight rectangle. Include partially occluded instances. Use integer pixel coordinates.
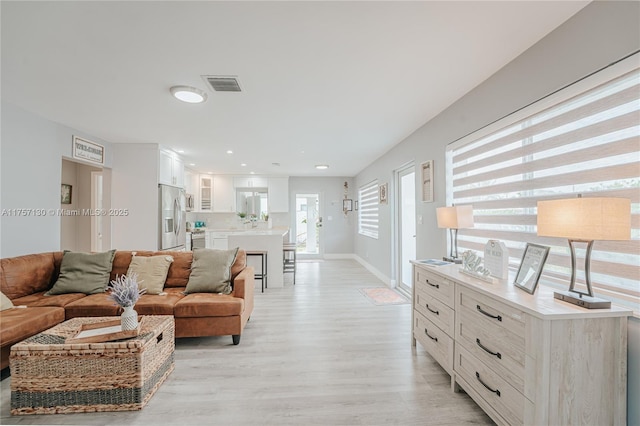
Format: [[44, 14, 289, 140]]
[[9, 315, 175, 415]]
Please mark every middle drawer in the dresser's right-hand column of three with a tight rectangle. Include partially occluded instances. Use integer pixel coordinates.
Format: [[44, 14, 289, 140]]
[[455, 312, 526, 393]]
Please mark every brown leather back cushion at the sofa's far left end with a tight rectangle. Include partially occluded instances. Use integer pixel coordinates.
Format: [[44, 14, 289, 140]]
[[0, 252, 57, 300]]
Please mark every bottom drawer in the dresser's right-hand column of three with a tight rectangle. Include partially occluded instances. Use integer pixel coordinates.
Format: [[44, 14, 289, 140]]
[[455, 345, 530, 425]]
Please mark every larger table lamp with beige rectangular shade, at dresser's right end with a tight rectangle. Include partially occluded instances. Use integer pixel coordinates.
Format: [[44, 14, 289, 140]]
[[538, 195, 631, 309]]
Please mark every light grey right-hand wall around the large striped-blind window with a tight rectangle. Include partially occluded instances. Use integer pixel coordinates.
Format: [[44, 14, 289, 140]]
[[354, 1, 640, 424]]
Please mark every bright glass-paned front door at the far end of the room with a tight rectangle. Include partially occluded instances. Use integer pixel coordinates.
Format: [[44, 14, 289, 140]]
[[294, 193, 323, 259]]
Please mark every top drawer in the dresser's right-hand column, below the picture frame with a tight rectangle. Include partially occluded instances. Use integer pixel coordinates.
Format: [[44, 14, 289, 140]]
[[455, 286, 525, 342]]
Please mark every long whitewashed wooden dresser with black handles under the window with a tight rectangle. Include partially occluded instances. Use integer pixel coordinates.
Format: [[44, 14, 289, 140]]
[[412, 261, 632, 425]]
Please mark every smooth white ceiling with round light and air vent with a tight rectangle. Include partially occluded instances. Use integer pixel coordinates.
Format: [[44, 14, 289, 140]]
[[1, 1, 588, 176]]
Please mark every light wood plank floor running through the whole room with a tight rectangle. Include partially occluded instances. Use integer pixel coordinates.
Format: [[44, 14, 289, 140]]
[[0, 260, 492, 425]]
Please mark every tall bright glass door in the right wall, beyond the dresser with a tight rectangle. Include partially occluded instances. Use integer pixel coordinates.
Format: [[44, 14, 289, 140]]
[[395, 163, 416, 294]]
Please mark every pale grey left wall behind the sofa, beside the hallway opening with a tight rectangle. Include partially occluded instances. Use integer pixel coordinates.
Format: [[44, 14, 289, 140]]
[[0, 101, 112, 257]]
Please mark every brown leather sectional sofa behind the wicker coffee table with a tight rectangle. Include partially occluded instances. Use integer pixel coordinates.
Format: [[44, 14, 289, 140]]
[[0, 250, 254, 369]]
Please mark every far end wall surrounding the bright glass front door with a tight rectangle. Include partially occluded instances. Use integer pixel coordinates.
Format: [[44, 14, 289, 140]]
[[289, 176, 358, 255]]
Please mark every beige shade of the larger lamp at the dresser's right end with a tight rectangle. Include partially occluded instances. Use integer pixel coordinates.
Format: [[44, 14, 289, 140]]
[[538, 197, 631, 241]]
